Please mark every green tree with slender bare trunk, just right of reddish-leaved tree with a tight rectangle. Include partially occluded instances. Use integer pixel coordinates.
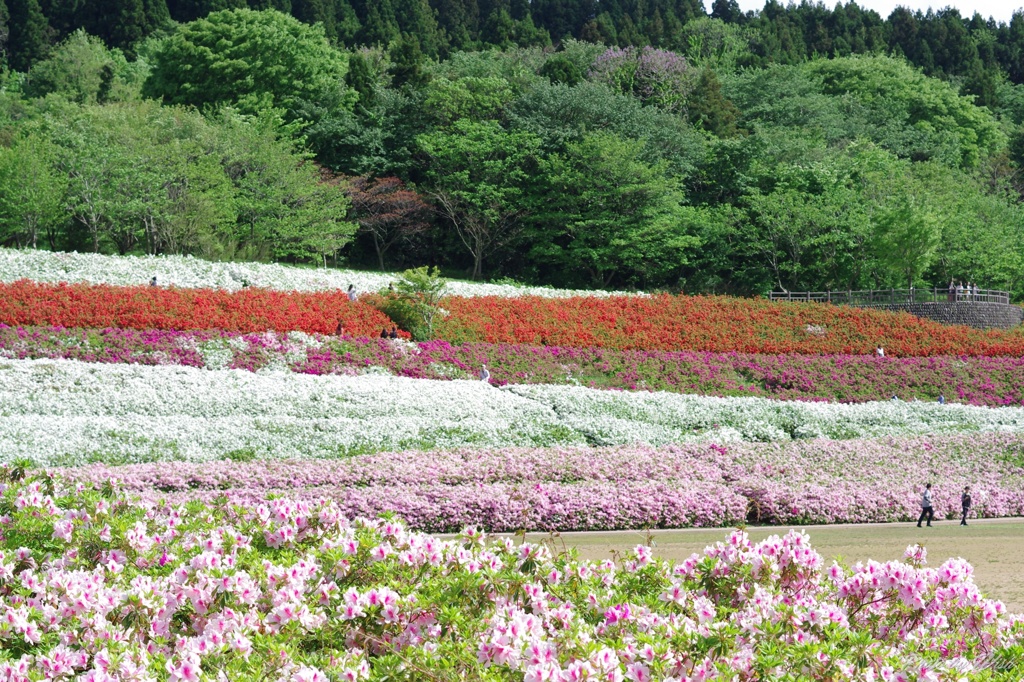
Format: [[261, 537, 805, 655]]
[[418, 119, 540, 280]]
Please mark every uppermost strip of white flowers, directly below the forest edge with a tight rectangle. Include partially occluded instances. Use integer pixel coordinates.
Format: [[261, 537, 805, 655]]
[[0, 249, 621, 297]]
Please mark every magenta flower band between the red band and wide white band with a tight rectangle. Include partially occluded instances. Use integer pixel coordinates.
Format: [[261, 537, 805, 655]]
[[6, 325, 1024, 407]]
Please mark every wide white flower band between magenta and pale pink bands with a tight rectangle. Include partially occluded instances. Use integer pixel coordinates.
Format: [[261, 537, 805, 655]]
[[0, 359, 1024, 465]]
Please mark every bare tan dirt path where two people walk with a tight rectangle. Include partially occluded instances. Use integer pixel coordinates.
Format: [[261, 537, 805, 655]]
[[529, 519, 1024, 613]]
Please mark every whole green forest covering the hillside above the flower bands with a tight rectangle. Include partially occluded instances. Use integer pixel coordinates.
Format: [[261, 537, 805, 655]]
[[0, 0, 1024, 298]]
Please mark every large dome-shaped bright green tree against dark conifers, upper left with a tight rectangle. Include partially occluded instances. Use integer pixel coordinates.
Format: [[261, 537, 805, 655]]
[[143, 9, 353, 114]]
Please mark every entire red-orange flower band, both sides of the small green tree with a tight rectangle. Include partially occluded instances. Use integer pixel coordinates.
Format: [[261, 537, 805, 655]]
[[6, 280, 1024, 357]]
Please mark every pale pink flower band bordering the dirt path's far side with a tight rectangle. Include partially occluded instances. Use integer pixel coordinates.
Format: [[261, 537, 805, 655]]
[[61, 433, 1024, 531]]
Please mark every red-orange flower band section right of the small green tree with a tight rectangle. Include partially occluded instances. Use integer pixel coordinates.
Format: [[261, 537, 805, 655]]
[[438, 294, 1024, 357]]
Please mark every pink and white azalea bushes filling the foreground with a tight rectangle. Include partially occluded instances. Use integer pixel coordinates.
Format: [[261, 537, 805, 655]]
[[0, 468, 1024, 682]]
